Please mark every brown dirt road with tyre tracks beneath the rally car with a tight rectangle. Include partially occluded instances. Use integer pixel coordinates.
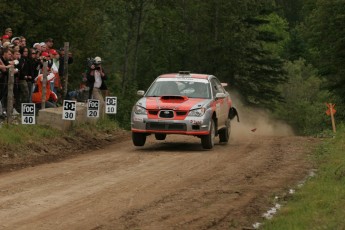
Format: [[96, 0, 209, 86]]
[[0, 126, 317, 230]]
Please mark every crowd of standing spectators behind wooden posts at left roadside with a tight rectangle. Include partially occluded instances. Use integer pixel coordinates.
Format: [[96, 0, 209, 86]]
[[0, 28, 73, 116]]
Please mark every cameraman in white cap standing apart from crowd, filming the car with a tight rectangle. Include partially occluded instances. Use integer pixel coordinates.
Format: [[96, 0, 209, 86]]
[[86, 57, 107, 111]]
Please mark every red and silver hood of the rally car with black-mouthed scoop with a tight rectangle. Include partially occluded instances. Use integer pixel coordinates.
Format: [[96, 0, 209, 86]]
[[137, 96, 211, 111]]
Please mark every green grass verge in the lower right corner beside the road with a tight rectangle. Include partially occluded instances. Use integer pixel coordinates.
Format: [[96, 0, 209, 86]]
[[260, 125, 345, 230]]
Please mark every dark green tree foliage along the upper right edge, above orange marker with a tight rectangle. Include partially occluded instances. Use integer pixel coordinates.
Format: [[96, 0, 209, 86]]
[[301, 0, 345, 117]]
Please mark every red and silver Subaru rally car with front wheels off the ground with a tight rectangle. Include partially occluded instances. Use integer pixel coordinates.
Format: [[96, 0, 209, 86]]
[[131, 71, 239, 149]]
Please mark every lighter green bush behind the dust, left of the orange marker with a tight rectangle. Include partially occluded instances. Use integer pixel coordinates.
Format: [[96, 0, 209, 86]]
[[276, 59, 332, 135]]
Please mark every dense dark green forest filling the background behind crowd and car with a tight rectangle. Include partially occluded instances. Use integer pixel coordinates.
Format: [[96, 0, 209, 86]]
[[0, 0, 345, 135]]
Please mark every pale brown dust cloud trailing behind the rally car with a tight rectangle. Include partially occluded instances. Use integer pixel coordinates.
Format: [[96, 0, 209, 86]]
[[231, 92, 294, 138]]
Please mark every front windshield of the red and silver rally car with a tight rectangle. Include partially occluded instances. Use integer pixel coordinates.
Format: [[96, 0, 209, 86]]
[[146, 79, 211, 98]]
